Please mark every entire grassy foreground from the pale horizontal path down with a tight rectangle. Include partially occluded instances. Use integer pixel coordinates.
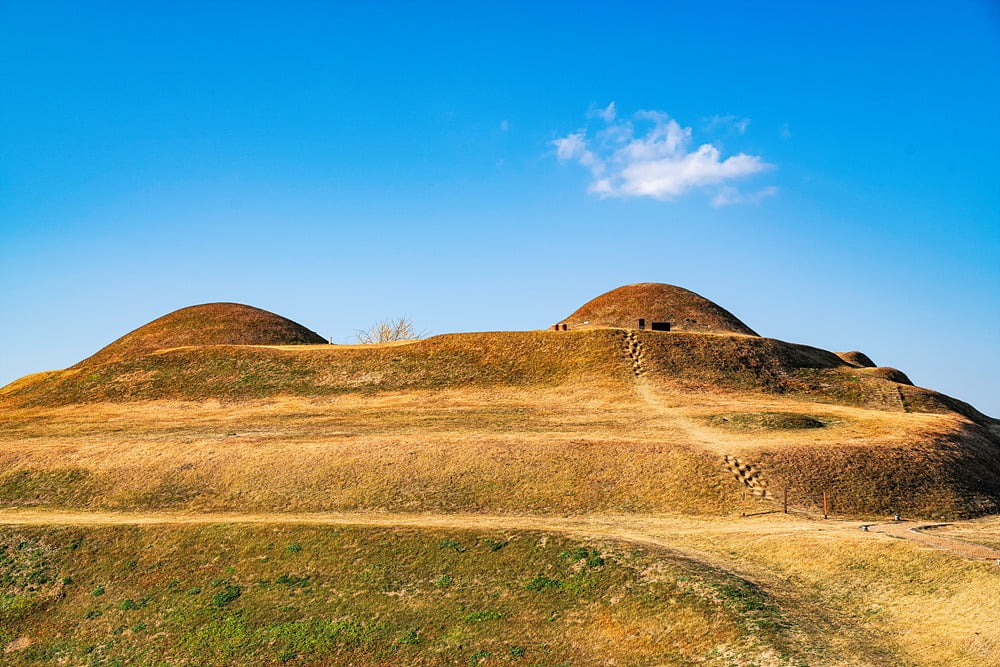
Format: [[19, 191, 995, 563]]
[[0, 513, 1000, 667]]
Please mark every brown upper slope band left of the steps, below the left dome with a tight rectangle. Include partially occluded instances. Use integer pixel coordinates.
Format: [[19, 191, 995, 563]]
[[0, 331, 629, 407]]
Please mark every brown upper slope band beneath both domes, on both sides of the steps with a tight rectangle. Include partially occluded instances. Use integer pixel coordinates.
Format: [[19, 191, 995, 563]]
[[0, 329, 976, 422]]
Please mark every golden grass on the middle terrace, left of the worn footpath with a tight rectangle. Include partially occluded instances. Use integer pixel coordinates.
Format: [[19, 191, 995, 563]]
[[0, 388, 731, 512]]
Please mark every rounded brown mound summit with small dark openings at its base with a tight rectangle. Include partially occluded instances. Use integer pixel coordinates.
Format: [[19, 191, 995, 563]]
[[560, 283, 757, 336]]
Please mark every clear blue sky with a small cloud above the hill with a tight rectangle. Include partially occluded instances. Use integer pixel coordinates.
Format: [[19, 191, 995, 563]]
[[0, 0, 1000, 415]]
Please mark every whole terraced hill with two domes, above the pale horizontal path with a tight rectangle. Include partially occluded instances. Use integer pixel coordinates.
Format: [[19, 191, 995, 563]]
[[0, 283, 1000, 516]]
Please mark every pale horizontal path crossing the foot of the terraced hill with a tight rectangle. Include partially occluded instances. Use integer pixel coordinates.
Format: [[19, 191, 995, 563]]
[[0, 509, 1000, 564]]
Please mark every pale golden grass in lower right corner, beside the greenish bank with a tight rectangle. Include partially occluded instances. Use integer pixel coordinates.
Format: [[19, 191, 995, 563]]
[[648, 517, 1000, 667]]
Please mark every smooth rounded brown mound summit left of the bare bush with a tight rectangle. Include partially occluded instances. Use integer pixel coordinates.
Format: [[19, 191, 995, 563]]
[[77, 303, 326, 366]]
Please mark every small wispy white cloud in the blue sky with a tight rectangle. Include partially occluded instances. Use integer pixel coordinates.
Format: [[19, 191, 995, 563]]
[[552, 102, 777, 206]]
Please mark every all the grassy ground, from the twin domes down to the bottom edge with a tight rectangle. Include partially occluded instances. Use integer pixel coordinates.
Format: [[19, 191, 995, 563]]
[[0, 284, 1000, 667]]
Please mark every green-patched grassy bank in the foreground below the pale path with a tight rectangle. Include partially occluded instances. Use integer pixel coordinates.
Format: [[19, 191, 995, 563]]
[[0, 525, 804, 666]]
